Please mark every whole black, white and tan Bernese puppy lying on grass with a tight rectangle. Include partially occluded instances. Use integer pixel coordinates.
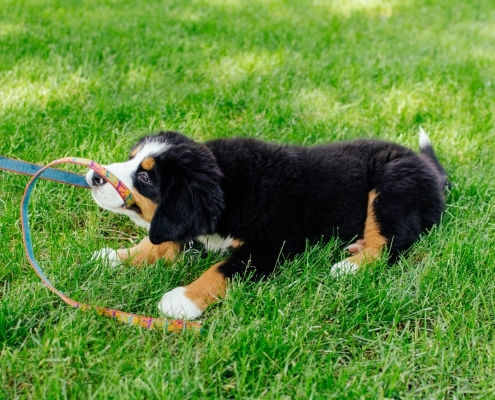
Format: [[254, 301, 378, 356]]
[[86, 130, 447, 319]]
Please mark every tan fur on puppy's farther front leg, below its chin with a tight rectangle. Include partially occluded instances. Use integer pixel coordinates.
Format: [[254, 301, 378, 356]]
[[117, 237, 182, 267]]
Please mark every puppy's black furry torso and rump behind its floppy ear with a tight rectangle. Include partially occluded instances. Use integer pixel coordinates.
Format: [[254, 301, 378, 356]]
[[206, 139, 444, 258]]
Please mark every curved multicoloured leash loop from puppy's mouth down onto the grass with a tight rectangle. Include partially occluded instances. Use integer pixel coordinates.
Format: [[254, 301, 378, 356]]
[[21, 157, 201, 333]]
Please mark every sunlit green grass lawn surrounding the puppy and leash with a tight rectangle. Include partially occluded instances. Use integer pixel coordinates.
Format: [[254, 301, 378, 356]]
[[0, 0, 495, 399]]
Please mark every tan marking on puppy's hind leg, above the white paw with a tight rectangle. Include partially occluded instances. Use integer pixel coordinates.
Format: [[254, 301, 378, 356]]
[[347, 190, 387, 265]]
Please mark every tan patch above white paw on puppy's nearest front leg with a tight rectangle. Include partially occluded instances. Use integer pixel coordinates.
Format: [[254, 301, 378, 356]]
[[184, 261, 227, 311]]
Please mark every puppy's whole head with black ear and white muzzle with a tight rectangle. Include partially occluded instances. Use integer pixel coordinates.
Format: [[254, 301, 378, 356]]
[[86, 132, 224, 244]]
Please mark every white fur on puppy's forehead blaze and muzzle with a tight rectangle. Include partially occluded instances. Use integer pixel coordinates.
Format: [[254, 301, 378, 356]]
[[86, 141, 170, 229]]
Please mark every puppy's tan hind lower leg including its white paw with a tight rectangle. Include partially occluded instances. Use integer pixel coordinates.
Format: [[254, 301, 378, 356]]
[[331, 190, 388, 275]]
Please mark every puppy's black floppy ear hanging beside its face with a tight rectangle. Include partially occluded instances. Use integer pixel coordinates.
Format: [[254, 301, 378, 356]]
[[149, 141, 224, 244]]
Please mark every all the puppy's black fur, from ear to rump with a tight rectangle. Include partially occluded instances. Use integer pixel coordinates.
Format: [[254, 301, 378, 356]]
[[138, 132, 445, 277]]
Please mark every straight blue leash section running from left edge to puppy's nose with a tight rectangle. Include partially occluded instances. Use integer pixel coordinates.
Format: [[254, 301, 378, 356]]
[[0, 156, 89, 189]]
